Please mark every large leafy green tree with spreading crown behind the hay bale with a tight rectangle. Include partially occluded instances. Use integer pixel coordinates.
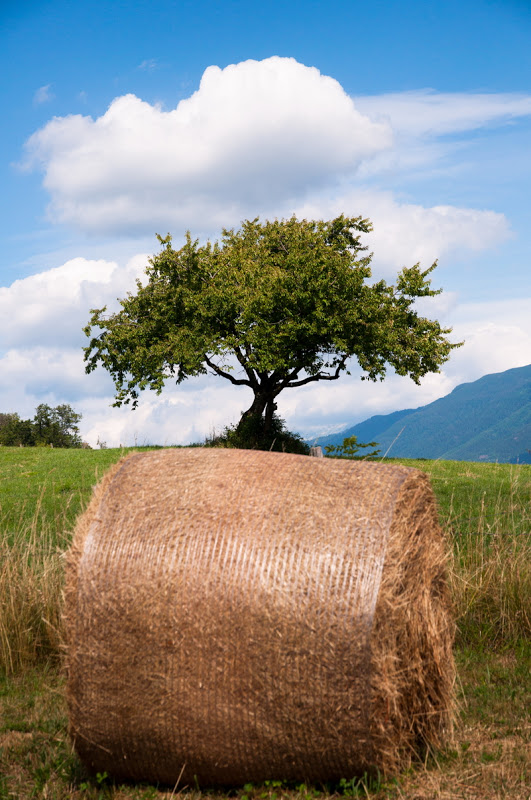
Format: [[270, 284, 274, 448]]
[[84, 216, 458, 430]]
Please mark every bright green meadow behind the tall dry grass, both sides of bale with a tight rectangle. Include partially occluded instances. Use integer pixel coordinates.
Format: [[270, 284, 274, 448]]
[[0, 447, 531, 536]]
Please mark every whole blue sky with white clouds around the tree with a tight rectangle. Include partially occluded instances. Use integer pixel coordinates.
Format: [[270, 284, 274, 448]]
[[0, 0, 531, 445]]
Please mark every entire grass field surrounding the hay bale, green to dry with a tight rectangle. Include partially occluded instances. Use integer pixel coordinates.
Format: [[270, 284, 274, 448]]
[[0, 448, 531, 800]]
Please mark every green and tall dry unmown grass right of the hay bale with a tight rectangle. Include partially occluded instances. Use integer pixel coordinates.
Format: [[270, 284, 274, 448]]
[[394, 460, 531, 648]]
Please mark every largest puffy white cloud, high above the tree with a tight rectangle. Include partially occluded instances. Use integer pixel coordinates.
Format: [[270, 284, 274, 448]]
[[22, 56, 392, 233]]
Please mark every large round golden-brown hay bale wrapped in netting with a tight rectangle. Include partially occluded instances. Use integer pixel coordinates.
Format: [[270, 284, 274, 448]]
[[65, 448, 454, 785]]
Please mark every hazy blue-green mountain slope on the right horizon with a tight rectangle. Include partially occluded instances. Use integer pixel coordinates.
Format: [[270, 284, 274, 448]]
[[312, 364, 531, 464]]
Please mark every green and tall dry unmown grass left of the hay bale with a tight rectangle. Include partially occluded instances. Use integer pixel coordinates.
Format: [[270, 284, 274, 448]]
[[0, 447, 160, 672]]
